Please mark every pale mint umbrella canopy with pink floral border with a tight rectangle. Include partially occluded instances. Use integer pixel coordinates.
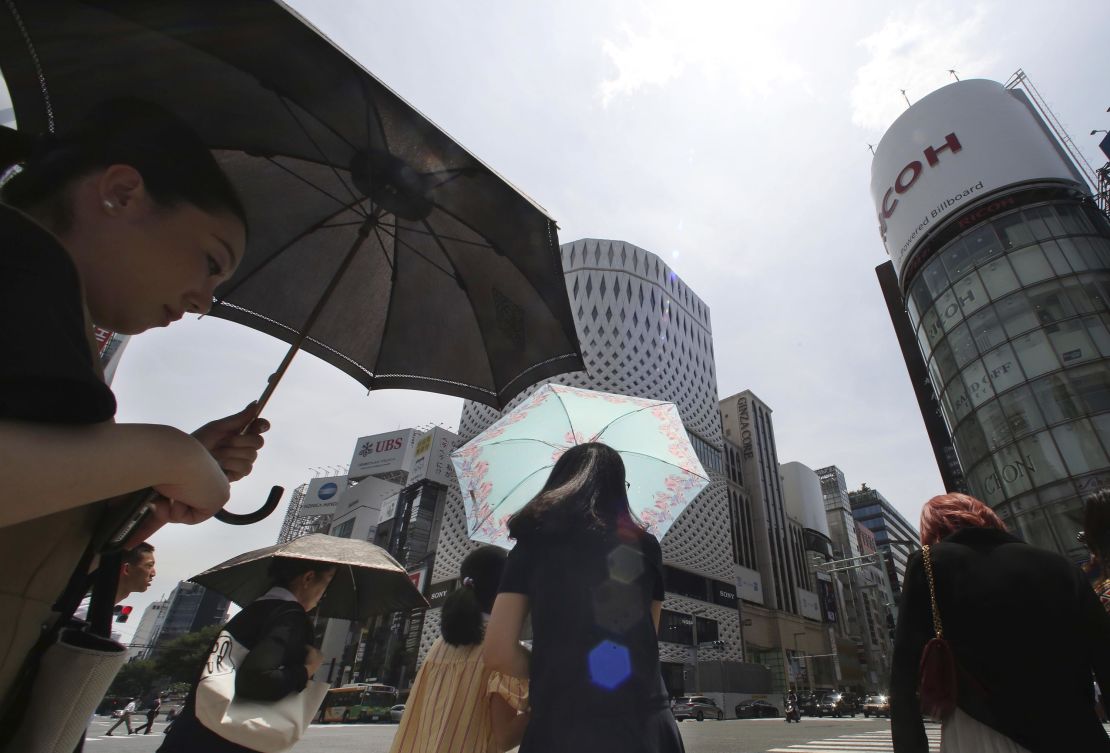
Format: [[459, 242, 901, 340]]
[[451, 384, 709, 549]]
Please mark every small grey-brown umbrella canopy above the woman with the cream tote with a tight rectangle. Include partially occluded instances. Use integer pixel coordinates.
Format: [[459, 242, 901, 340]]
[[189, 533, 427, 620]]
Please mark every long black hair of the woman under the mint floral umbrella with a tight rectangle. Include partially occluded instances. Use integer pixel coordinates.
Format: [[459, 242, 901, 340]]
[[508, 442, 644, 539]]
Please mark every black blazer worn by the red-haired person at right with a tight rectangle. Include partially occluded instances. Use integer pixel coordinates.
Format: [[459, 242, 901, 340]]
[[890, 529, 1110, 753]]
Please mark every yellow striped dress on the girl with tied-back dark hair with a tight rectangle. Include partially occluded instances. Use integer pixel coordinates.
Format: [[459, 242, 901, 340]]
[[390, 637, 528, 753]]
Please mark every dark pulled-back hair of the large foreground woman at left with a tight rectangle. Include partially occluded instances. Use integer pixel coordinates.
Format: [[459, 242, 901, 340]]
[[0, 99, 246, 230]]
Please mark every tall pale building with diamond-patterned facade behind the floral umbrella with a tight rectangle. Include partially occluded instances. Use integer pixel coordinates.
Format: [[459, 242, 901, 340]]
[[420, 239, 743, 694]]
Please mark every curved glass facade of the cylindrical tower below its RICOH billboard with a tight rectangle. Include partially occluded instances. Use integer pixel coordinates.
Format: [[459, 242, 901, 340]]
[[906, 197, 1110, 554]]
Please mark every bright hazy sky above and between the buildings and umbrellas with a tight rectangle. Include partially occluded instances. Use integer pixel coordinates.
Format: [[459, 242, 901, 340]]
[[0, 0, 1110, 636]]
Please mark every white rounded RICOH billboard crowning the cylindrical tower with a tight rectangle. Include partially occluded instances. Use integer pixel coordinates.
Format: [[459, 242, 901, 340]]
[[871, 80, 1084, 283]]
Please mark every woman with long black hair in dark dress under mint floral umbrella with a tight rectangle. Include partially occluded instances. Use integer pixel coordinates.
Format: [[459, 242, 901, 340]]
[[485, 442, 684, 753]]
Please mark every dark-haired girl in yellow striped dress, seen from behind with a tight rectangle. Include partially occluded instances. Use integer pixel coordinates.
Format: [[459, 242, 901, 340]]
[[390, 546, 528, 753]]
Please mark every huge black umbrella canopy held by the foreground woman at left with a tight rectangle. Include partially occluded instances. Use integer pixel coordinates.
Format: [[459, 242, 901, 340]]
[[0, 0, 583, 408]]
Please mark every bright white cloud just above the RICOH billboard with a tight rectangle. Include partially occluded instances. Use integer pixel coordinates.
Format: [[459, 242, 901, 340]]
[[851, 3, 995, 131]]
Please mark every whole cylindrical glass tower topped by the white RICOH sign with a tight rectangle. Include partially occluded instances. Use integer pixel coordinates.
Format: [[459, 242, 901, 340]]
[[871, 80, 1110, 554]]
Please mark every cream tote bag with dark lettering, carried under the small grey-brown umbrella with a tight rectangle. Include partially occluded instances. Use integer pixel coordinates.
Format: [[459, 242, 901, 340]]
[[196, 631, 330, 753]]
